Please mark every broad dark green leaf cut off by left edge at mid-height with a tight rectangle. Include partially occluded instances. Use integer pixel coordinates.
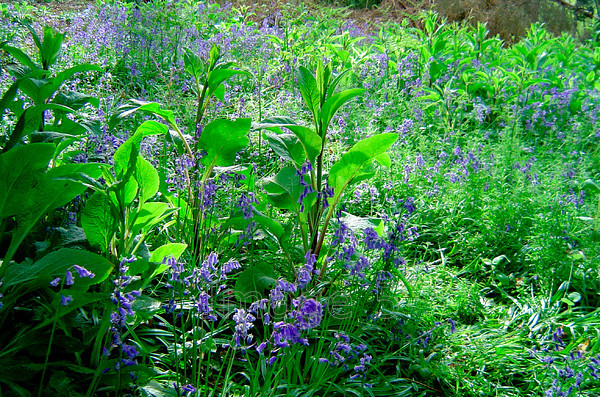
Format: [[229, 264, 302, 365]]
[[0, 143, 54, 219]]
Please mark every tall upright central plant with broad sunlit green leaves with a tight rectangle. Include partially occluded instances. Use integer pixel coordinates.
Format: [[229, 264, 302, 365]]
[[257, 62, 397, 271]]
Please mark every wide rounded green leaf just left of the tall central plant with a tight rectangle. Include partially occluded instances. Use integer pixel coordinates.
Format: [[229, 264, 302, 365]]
[[198, 119, 250, 167]]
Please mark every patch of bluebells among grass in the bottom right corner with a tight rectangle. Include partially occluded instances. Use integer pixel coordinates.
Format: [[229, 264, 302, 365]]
[[529, 326, 600, 397]]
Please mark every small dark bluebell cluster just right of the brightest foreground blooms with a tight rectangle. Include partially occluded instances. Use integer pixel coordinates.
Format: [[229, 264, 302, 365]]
[[319, 332, 373, 387]]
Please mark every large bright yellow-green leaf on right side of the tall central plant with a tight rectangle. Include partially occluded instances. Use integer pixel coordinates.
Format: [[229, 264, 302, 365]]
[[329, 133, 398, 202]]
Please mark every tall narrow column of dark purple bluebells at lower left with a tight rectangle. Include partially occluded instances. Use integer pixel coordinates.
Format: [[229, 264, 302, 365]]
[[103, 257, 142, 372]]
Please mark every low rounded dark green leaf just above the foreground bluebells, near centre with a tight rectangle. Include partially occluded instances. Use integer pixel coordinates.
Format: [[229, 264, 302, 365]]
[[235, 262, 277, 302]]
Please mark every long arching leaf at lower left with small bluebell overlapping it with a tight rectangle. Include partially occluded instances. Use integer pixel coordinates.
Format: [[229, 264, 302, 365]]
[[4, 248, 114, 291]]
